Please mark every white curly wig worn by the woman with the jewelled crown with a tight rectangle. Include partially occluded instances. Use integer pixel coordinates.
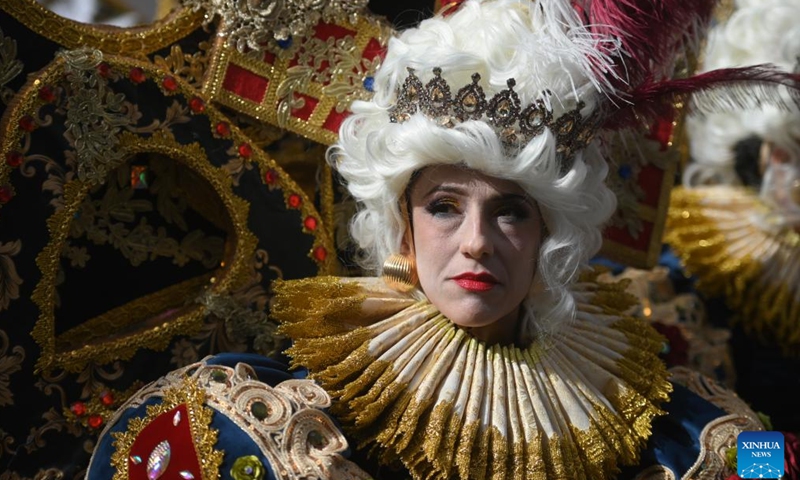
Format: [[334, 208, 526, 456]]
[[329, 0, 619, 338]]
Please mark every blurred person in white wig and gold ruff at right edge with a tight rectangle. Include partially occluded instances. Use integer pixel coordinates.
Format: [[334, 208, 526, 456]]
[[666, 0, 800, 430]]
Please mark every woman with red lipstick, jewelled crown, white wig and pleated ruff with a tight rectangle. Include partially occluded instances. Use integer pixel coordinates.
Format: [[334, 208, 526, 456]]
[[88, 0, 791, 479]]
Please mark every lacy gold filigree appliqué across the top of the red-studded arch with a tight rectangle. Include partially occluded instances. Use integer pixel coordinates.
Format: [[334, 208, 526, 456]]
[[59, 49, 133, 184]]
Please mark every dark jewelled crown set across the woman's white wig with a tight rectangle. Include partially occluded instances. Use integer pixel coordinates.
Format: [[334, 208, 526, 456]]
[[389, 67, 597, 158]]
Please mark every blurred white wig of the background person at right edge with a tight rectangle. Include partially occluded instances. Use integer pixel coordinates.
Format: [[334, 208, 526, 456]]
[[683, 0, 800, 187]]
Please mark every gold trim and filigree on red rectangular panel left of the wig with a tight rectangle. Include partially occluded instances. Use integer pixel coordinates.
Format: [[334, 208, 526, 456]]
[[203, 15, 392, 145]]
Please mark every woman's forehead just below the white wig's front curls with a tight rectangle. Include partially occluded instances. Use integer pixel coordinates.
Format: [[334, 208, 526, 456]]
[[411, 165, 525, 197]]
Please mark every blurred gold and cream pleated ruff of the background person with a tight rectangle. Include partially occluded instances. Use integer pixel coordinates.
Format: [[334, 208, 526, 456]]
[[665, 187, 800, 355]]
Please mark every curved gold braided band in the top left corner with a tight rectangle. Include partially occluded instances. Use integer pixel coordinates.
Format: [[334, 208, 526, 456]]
[[0, 0, 203, 58]]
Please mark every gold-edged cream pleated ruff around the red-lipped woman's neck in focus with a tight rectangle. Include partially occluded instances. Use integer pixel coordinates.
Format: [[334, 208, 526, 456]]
[[272, 277, 671, 479]]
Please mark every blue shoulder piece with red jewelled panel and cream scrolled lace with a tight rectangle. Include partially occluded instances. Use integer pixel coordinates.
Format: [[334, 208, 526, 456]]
[[86, 354, 369, 480]]
